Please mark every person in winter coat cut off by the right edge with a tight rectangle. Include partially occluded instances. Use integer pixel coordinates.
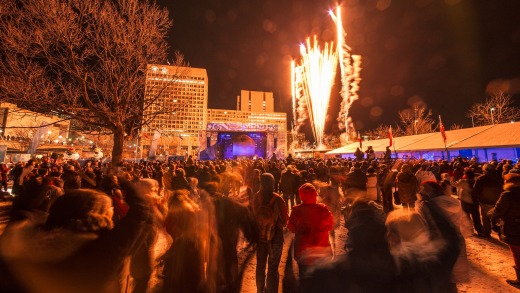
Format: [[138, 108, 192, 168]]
[[489, 173, 520, 288]]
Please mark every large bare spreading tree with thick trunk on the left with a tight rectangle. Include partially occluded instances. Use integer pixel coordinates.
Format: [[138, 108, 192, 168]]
[[0, 0, 183, 164]]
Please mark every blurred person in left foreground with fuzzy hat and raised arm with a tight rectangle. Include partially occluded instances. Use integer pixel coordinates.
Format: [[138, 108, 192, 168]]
[[0, 181, 150, 293]]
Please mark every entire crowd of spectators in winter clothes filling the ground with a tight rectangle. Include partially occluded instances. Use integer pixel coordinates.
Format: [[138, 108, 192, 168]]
[[0, 150, 520, 292]]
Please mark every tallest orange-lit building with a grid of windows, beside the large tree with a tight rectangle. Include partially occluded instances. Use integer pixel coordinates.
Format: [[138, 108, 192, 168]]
[[141, 64, 208, 155]]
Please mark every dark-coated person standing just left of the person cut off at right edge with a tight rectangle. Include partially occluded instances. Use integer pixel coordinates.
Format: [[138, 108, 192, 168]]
[[473, 164, 504, 237]]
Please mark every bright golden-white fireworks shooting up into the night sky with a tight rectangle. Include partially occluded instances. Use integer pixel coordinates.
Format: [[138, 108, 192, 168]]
[[291, 6, 361, 146]]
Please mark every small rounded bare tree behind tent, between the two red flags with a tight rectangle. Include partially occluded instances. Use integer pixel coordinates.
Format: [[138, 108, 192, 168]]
[[399, 105, 435, 135]]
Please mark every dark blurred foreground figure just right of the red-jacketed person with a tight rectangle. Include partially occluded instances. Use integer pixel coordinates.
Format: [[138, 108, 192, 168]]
[[300, 199, 396, 293]]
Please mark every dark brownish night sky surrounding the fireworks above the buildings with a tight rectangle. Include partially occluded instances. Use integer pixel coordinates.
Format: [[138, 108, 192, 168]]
[[158, 0, 520, 132]]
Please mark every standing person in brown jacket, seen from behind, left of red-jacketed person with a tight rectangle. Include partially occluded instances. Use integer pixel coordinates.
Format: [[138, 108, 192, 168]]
[[251, 173, 289, 292]]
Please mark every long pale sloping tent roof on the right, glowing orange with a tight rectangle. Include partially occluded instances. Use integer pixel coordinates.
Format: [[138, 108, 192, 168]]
[[326, 123, 520, 155]]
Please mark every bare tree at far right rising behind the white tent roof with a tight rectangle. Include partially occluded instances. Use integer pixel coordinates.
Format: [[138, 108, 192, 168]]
[[466, 92, 520, 126]]
